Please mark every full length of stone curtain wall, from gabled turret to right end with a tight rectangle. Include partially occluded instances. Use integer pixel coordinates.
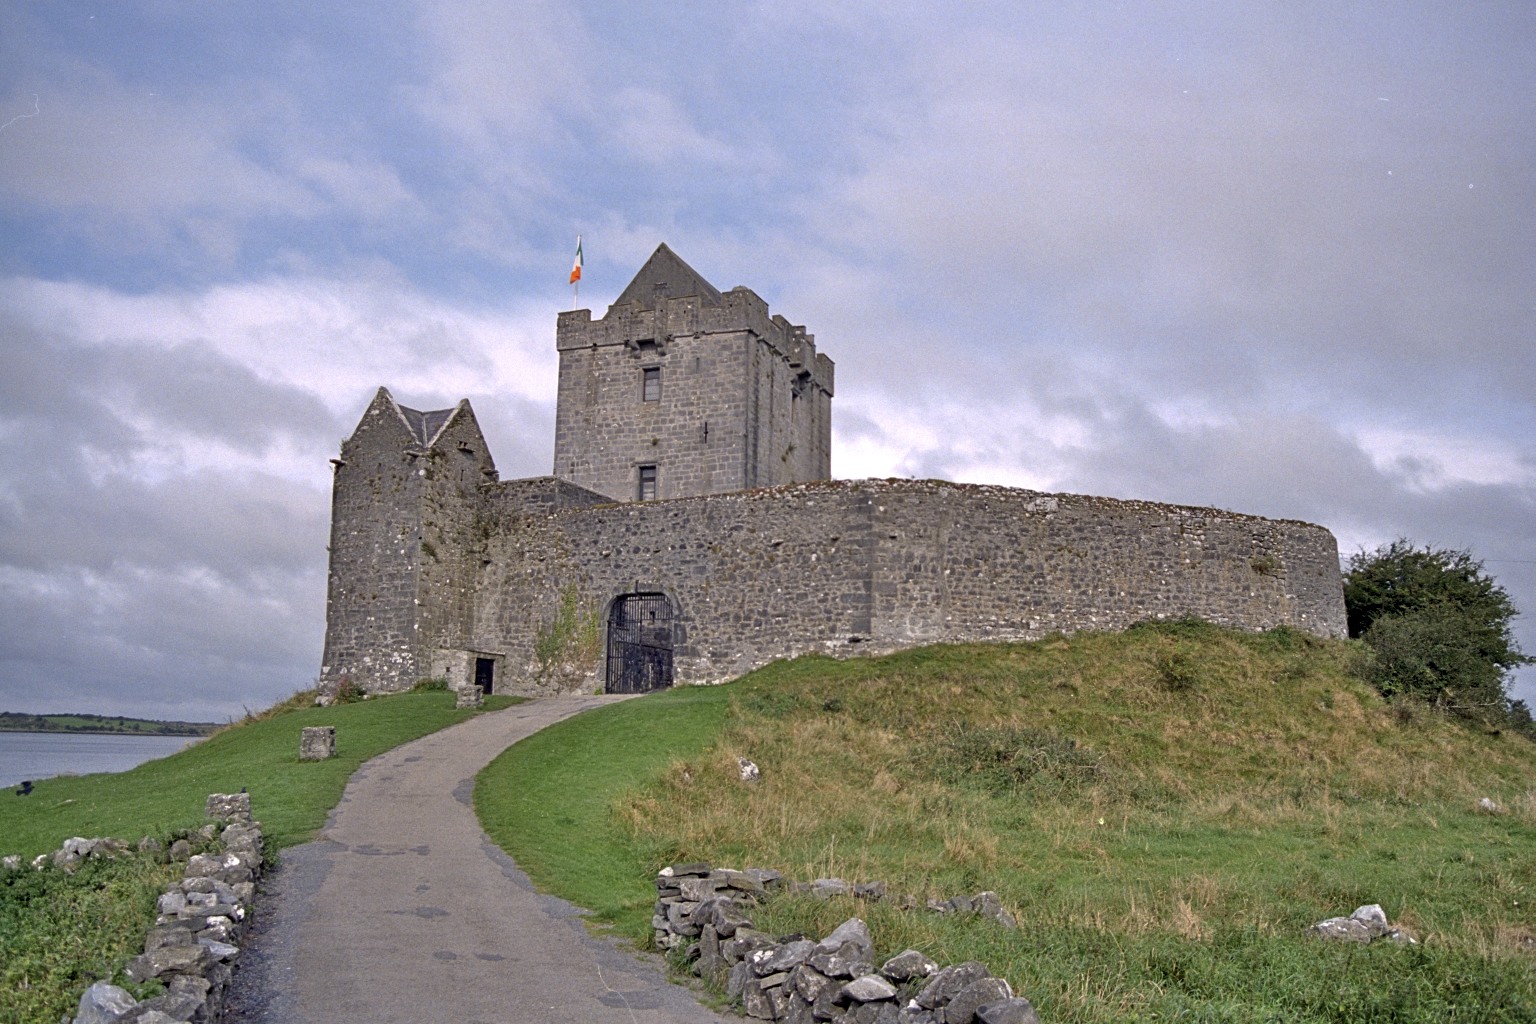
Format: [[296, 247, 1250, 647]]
[[468, 481, 1344, 696]]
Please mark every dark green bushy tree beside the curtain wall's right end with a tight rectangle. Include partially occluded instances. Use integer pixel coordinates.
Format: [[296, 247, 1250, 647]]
[[1344, 539, 1533, 732]]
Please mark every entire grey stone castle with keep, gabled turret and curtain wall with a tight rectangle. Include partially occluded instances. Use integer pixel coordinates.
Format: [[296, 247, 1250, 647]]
[[321, 246, 1344, 694]]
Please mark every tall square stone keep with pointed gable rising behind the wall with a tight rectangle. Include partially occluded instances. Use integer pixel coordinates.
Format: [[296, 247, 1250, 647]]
[[554, 246, 833, 502]]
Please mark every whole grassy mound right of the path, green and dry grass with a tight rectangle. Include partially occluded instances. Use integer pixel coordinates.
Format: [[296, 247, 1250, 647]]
[[476, 623, 1536, 1021]]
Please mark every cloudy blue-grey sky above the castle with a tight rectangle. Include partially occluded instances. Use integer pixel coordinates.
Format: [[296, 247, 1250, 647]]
[[0, 0, 1536, 720]]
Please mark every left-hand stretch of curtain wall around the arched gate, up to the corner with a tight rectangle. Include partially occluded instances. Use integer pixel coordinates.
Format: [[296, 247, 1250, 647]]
[[476, 485, 869, 686]]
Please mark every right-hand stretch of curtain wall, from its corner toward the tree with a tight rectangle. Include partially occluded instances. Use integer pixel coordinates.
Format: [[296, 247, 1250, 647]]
[[869, 481, 1344, 643]]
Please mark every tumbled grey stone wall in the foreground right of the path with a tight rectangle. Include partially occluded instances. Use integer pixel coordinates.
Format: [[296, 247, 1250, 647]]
[[651, 864, 1038, 1024]]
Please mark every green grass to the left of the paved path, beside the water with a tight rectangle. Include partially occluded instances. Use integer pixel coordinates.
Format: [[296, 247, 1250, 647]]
[[0, 692, 516, 1024]]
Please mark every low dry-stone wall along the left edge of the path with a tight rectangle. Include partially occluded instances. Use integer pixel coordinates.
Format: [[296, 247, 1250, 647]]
[[72, 794, 263, 1024]]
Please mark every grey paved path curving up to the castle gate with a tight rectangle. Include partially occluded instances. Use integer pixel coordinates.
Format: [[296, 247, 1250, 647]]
[[230, 697, 723, 1024]]
